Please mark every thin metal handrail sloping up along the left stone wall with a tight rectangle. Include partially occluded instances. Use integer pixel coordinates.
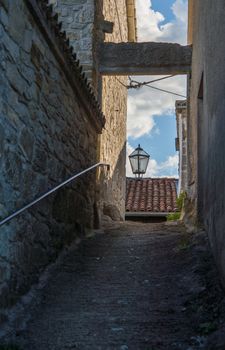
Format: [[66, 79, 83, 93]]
[[0, 163, 110, 226]]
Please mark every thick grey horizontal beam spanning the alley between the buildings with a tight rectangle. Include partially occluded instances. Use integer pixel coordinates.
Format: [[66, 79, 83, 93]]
[[98, 42, 192, 75]]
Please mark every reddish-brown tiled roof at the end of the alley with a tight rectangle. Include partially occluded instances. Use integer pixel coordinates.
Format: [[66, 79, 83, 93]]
[[126, 178, 177, 213]]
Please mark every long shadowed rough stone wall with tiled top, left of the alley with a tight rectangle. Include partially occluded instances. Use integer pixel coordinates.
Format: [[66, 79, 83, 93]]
[[0, 0, 103, 307]]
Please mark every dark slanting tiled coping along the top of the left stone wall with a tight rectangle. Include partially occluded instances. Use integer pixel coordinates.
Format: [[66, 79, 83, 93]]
[[25, 0, 105, 133]]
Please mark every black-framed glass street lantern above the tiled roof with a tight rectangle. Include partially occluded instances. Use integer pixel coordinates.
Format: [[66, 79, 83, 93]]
[[129, 145, 150, 178]]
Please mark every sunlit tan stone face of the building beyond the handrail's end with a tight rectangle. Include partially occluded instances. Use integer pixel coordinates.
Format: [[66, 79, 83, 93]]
[[100, 0, 128, 219]]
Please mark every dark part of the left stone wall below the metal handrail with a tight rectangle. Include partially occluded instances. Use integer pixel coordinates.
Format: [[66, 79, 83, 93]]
[[0, 165, 99, 308]]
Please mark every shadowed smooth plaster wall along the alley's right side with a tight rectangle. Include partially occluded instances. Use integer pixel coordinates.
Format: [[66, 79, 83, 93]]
[[188, 0, 225, 283]]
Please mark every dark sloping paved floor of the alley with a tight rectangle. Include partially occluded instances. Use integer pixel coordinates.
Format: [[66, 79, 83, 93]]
[[5, 222, 225, 350]]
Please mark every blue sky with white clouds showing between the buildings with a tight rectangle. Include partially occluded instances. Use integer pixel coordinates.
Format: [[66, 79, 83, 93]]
[[127, 0, 187, 177]]
